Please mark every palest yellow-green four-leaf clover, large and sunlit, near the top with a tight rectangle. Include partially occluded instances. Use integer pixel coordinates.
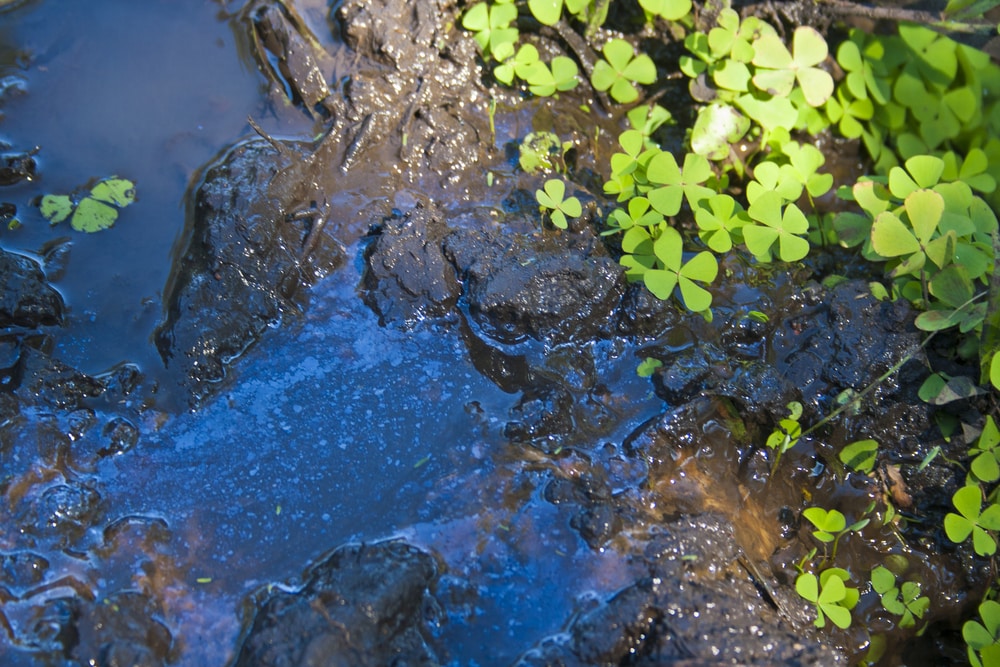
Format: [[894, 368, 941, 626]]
[[751, 26, 833, 107]]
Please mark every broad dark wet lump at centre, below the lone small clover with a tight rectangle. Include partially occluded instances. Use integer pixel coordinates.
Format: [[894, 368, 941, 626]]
[[445, 230, 625, 343]]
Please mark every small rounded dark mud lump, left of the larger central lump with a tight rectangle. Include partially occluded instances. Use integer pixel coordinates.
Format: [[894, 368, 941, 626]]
[[364, 205, 460, 323]]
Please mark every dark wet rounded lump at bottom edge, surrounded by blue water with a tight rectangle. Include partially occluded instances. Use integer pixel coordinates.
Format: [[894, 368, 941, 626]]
[[236, 541, 438, 667]]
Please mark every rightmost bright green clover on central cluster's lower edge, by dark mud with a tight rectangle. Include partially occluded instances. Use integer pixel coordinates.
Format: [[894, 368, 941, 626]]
[[743, 192, 809, 262]]
